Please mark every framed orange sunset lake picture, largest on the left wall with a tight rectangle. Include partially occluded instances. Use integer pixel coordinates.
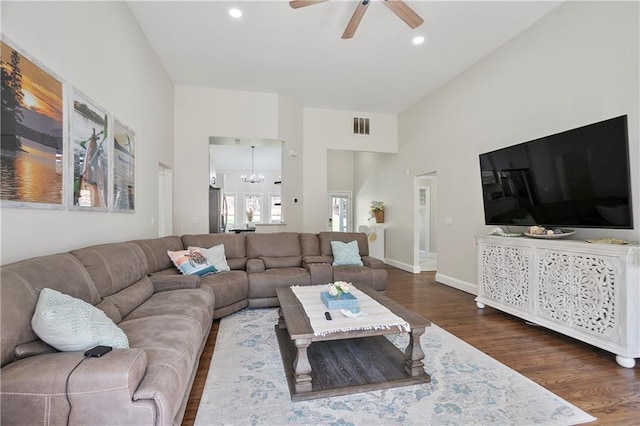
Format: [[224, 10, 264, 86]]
[[0, 39, 66, 208]]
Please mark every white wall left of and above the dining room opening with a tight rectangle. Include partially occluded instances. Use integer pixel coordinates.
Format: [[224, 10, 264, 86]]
[[173, 86, 284, 235]]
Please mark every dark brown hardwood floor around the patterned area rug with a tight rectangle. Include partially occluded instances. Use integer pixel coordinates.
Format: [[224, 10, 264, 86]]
[[182, 267, 640, 426]]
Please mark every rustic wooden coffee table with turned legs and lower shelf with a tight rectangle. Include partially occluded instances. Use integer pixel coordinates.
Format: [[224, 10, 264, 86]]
[[275, 285, 431, 401]]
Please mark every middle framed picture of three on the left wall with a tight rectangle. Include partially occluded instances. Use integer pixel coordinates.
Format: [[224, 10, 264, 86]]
[[69, 90, 111, 210]]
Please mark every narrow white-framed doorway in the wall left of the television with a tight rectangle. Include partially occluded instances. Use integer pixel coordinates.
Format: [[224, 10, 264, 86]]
[[414, 172, 438, 272]]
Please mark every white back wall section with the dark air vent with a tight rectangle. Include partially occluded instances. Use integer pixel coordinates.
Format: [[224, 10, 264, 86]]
[[303, 108, 398, 232]]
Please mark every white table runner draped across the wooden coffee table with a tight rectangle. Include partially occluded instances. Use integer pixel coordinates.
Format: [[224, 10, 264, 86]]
[[291, 285, 411, 336]]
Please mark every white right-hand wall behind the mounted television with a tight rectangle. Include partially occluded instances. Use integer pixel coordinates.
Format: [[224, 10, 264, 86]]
[[390, 2, 640, 290]]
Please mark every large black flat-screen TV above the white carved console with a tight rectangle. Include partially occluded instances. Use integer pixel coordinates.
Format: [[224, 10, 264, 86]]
[[480, 115, 633, 229]]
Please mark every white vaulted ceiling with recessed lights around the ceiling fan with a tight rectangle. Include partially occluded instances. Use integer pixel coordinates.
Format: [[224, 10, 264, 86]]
[[128, 0, 561, 114]]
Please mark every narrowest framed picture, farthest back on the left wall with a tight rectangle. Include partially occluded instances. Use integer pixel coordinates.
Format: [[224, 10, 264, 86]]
[[112, 120, 136, 211]]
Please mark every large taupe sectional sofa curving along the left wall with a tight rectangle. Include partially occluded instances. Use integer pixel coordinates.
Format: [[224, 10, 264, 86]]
[[0, 232, 387, 425]]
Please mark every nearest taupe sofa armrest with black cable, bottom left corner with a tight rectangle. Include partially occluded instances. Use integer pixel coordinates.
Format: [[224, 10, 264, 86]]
[[1, 349, 148, 424]]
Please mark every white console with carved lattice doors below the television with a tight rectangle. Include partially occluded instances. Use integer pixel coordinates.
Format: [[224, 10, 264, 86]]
[[475, 236, 640, 368]]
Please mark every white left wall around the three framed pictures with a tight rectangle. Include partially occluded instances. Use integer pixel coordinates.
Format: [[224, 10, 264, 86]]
[[0, 2, 173, 264]]
